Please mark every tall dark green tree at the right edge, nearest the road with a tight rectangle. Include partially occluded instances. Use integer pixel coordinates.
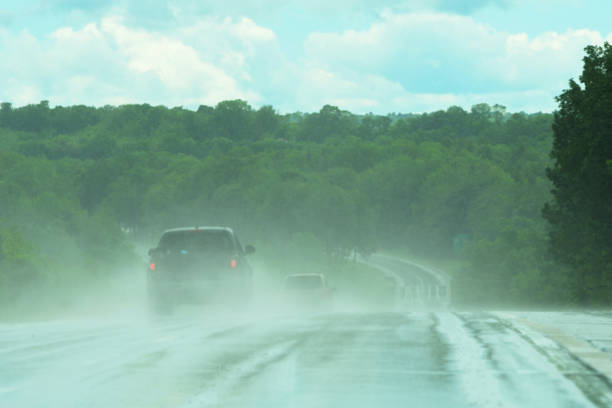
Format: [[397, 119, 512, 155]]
[[544, 43, 612, 303]]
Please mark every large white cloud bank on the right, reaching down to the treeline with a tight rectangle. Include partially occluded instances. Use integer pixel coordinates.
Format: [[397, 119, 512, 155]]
[[296, 10, 610, 111]]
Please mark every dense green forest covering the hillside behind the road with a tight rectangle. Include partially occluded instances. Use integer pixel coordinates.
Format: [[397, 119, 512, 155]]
[[0, 43, 612, 305]]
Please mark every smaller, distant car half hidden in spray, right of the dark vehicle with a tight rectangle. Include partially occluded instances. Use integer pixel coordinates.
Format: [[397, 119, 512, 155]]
[[282, 273, 335, 311]]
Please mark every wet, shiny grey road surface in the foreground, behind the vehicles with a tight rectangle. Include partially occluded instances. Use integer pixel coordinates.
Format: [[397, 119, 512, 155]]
[[0, 310, 612, 408]]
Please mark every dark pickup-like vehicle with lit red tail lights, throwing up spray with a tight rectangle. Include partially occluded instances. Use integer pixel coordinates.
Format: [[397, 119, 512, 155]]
[[147, 227, 255, 313]]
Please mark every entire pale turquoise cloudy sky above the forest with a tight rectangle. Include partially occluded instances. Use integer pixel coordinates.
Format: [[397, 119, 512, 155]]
[[0, 0, 612, 114]]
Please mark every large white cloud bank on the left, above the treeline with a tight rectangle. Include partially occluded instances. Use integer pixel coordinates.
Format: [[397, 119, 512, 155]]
[[0, 17, 274, 106]]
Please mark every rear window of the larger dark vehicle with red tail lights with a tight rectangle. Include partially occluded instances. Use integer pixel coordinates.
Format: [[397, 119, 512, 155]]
[[159, 230, 234, 252]]
